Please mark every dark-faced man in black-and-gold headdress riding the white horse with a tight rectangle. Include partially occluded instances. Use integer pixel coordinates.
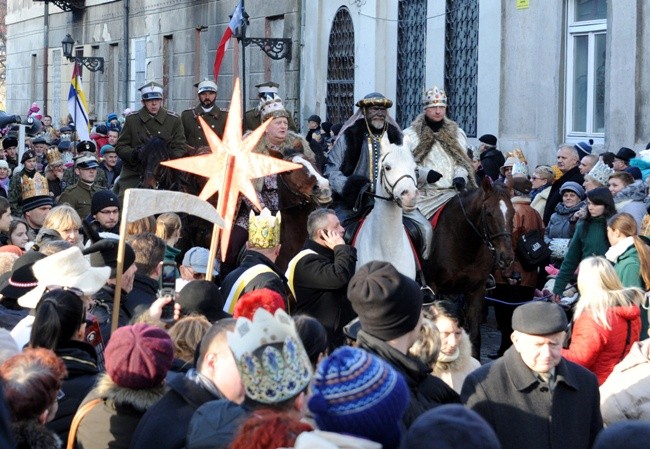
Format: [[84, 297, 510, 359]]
[[325, 92, 436, 259]]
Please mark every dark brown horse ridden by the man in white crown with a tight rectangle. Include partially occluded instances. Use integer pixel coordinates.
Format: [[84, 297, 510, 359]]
[[424, 179, 514, 358]]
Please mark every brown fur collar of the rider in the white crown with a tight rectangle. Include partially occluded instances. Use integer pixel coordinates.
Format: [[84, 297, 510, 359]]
[[410, 113, 478, 189]]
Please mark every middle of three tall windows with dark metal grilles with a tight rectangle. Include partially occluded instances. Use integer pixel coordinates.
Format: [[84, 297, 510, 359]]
[[395, 0, 427, 128]]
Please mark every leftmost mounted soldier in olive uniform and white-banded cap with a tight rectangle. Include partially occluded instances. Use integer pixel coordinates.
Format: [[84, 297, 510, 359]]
[[113, 82, 186, 197]]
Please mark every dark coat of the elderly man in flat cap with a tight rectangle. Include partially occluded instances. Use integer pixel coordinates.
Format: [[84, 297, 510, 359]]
[[461, 346, 603, 449]]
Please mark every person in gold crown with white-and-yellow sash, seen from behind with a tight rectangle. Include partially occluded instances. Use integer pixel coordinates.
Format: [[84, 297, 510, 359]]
[[221, 208, 288, 315]]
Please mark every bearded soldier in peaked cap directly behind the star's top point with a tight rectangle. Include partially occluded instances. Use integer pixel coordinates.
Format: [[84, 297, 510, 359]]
[[181, 79, 227, 149]]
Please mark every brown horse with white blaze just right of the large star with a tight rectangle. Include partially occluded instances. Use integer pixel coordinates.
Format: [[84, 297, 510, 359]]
[[270, 150, 332, 271]]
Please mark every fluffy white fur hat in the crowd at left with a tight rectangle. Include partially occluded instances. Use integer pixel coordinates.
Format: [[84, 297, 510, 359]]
[[18, 247, 111, 309]]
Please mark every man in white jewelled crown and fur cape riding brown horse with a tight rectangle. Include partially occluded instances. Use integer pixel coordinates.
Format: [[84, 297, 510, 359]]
[[404, 86, 476, 218]]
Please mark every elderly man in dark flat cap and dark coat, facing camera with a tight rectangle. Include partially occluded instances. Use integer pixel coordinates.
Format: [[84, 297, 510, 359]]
[[461, 301, 603, 449]]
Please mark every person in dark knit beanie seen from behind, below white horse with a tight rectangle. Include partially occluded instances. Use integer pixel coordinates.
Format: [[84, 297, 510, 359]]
[[348, 262, 460, 427]]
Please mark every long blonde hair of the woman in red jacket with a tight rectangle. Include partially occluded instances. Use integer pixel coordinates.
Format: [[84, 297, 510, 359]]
[[573, 256, 643, 330]]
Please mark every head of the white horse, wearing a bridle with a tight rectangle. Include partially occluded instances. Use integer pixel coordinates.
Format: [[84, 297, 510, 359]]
[[375, 144, 419, 211]]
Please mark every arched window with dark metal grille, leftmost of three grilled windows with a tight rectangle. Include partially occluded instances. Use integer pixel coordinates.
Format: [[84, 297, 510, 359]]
[[325, 7, 354, 124]]
